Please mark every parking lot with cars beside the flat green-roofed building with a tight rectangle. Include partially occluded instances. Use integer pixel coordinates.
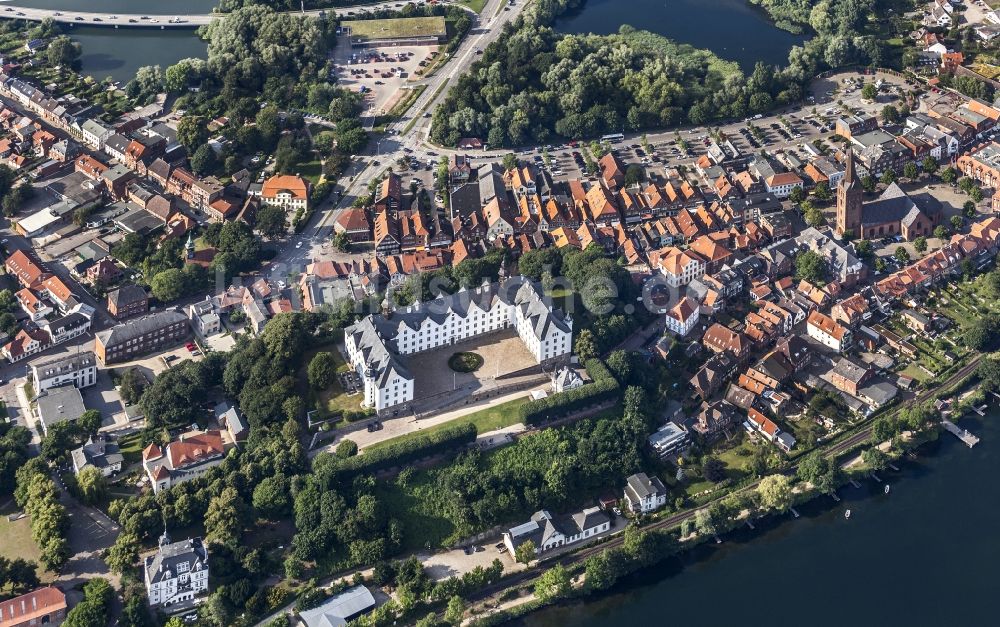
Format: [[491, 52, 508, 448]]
[[334, 37, 440, 115]]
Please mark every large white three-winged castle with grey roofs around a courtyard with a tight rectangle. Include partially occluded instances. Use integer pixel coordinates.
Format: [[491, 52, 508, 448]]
[[344, 277, 573, 411]]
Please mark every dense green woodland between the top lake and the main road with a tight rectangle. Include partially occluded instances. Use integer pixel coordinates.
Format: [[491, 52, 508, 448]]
[[431, 0, 884, 146]]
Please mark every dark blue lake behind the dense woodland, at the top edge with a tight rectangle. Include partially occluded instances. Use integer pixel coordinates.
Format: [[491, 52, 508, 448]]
[[555, 0, 806, 71]]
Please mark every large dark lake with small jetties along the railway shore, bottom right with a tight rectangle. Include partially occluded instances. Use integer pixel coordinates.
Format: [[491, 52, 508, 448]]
[[518, 410, 1000, 627]]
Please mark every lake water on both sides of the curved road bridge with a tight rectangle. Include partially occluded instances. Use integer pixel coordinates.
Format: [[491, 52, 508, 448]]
[[6, 0, 216, 84]]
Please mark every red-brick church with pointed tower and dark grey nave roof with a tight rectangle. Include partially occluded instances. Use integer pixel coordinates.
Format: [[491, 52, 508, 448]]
[[837, 148, 941, 241]]
